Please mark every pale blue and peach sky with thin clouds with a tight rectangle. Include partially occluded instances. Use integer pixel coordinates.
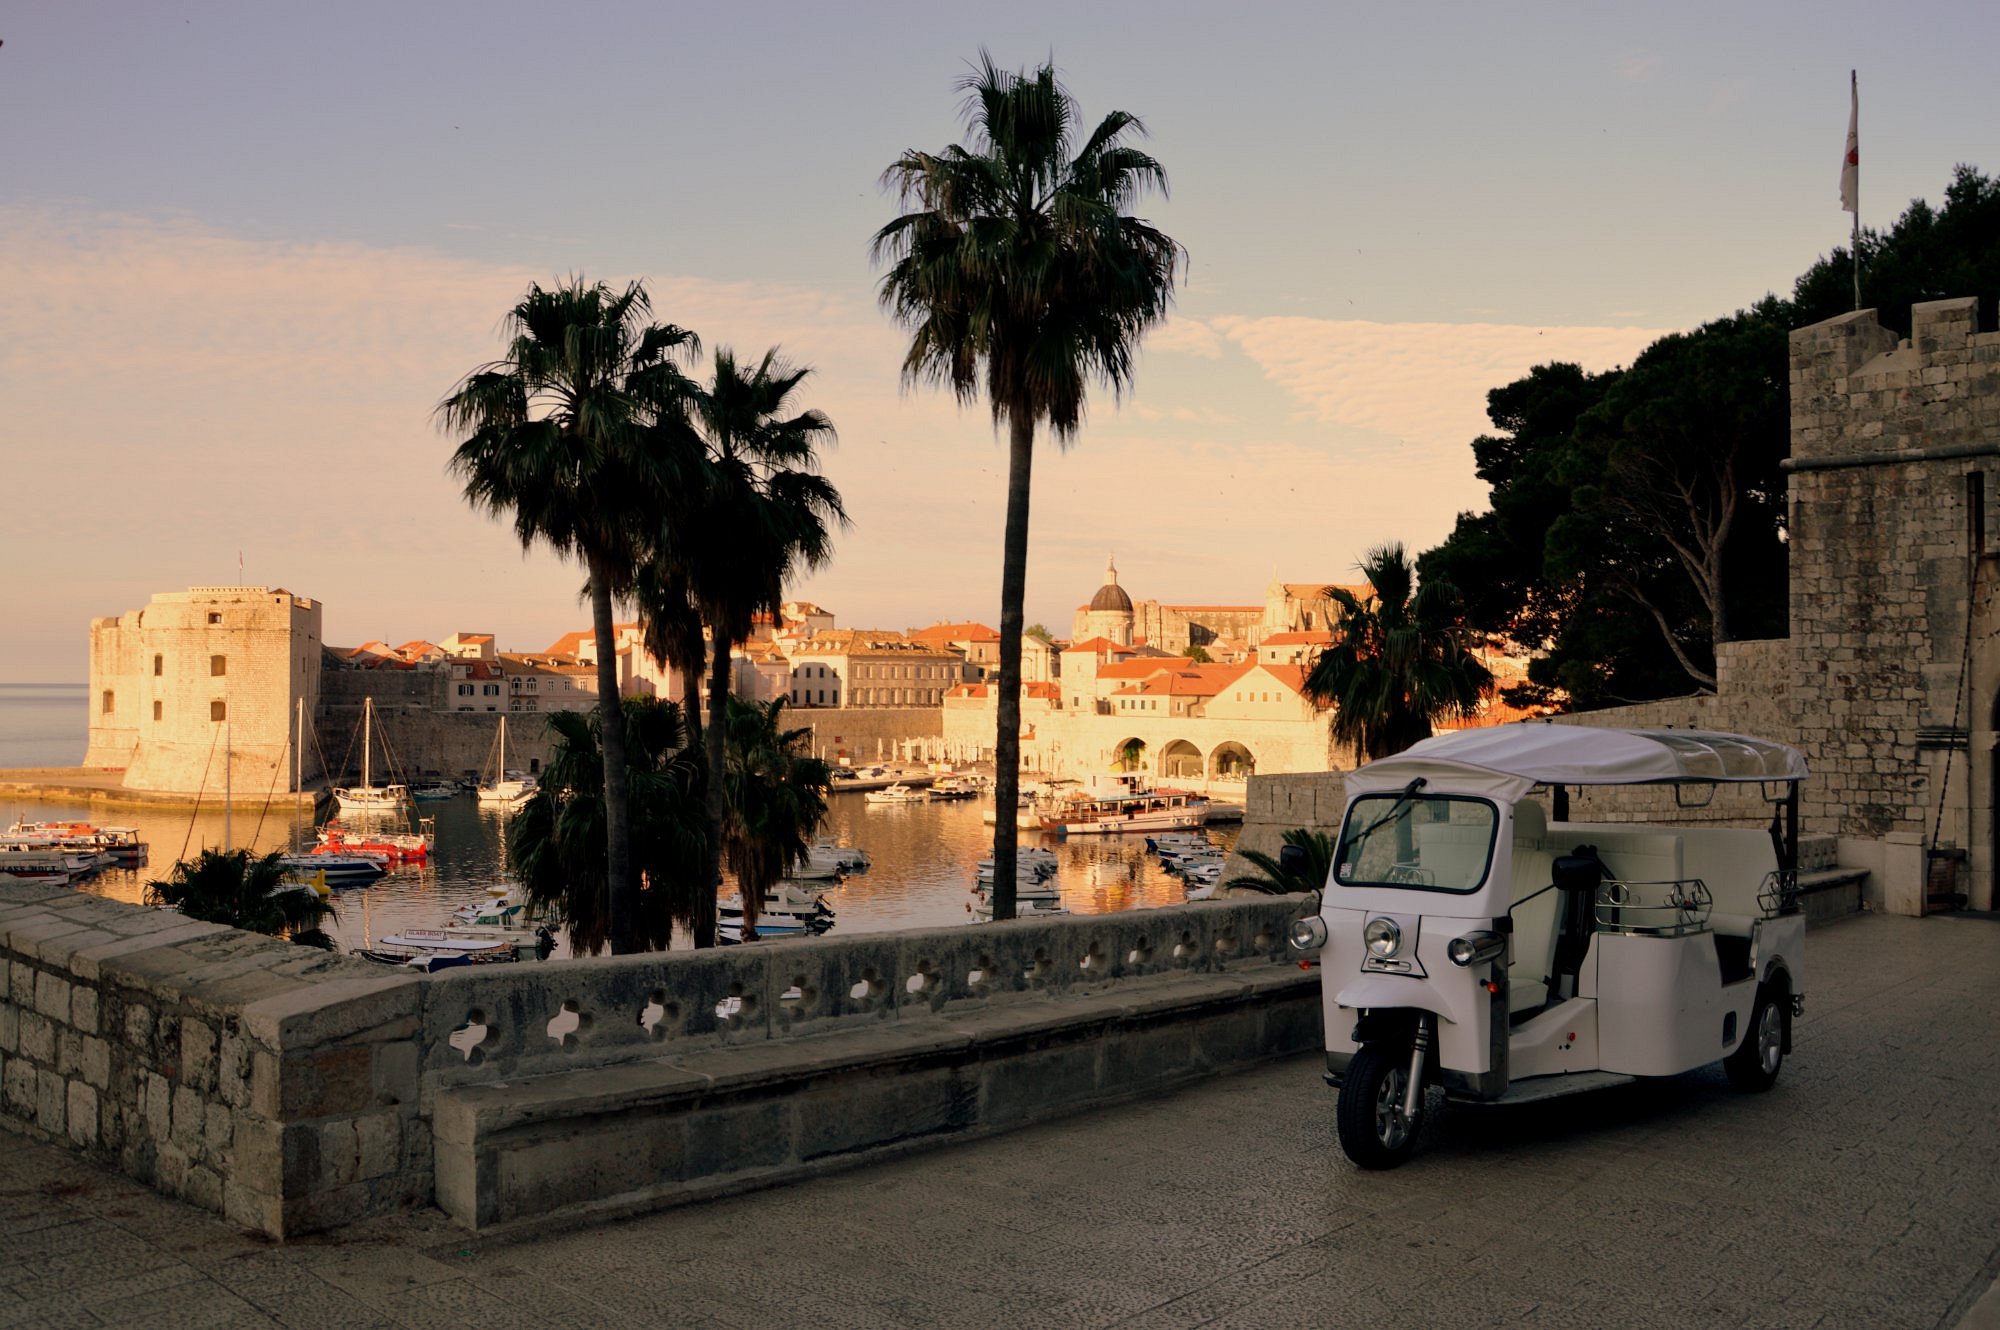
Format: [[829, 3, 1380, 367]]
[[0, 0, 2000, 682]]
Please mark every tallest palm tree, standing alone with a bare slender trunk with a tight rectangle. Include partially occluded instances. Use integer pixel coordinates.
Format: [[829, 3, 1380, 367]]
[[874, 52, 1186, 918]]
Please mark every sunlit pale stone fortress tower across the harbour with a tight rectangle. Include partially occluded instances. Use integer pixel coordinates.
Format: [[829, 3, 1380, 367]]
[[84, 586, 320, 800]]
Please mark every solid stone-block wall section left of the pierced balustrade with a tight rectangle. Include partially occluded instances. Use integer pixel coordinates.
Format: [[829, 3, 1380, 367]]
[[0, 886, 432, 1236]]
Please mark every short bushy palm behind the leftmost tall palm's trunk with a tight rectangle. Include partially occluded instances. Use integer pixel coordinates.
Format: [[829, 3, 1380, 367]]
[[506, 698, 714, 956]]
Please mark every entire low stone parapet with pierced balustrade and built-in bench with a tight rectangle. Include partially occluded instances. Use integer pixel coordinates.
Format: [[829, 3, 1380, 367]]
[[0, 886, 1320, 1238]]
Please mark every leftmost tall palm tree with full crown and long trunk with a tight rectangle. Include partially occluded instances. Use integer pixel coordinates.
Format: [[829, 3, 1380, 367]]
[[438, 278, 700, 952]]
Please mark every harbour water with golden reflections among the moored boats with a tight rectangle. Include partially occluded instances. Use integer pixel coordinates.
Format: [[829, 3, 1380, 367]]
[[23, 794, 1236, 956]]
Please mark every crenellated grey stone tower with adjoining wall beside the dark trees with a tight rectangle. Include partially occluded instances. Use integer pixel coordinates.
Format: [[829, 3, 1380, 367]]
[[1568, 298, 2000, 914]]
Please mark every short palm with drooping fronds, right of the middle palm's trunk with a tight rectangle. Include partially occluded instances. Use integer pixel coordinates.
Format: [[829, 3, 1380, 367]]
[[722, 698, 832, 942]]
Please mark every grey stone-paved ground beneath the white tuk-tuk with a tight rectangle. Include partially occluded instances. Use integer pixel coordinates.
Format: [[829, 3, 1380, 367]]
[[0, 918, 2000, 1330]]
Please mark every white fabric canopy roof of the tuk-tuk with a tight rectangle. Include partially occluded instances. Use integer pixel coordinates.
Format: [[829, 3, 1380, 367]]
[[1346, 722, 1808, 804]]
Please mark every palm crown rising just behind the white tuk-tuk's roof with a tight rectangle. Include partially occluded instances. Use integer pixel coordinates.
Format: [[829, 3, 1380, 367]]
[[1304, 542, 1494, 762]]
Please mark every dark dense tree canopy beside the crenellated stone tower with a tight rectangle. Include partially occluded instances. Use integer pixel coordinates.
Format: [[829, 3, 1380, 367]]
[[1418, 166, 2000, 710]]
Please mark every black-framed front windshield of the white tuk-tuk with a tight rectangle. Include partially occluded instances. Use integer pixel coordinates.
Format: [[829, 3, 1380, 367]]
[[1334, 792, 1500, 892]]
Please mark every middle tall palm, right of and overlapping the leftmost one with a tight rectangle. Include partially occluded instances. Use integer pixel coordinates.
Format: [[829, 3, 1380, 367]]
[[680, 348, 848, 946]]
